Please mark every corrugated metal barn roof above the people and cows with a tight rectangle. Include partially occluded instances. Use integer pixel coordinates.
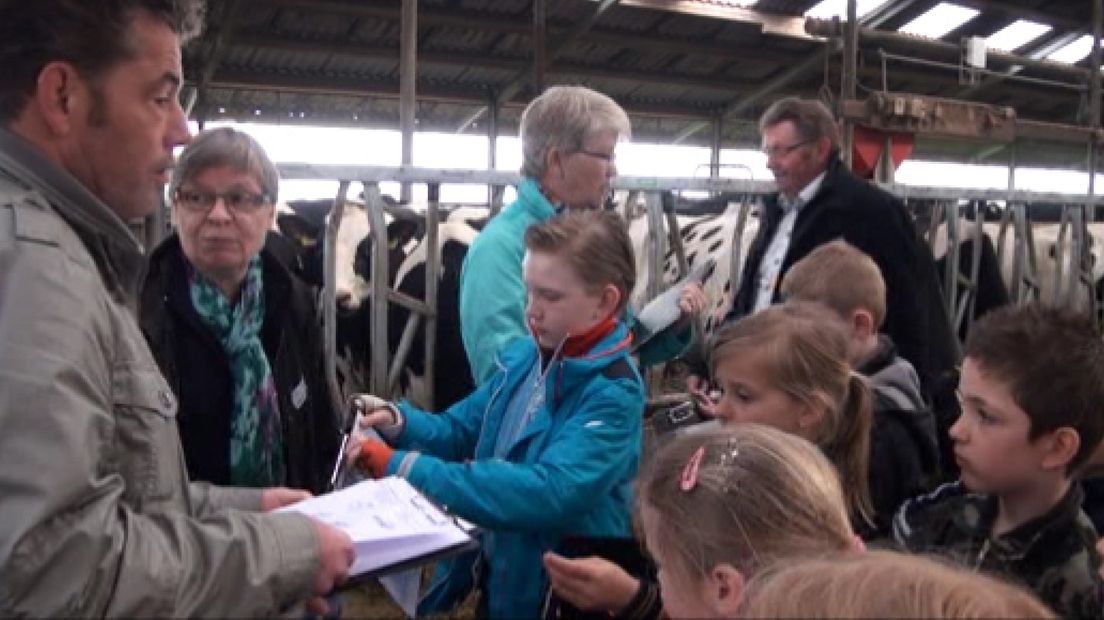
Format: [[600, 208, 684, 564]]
[[185, 0, 1089, 162]]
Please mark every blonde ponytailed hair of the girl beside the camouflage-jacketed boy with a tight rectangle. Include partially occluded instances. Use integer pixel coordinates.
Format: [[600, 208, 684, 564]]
[[712, 302, 873, 523]]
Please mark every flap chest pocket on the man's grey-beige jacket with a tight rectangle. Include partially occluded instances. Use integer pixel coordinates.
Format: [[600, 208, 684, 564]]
[[112, 365, 183, 507]]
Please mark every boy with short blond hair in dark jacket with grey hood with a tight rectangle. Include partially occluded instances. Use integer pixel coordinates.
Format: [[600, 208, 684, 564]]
[[782, 239, 940, 537]]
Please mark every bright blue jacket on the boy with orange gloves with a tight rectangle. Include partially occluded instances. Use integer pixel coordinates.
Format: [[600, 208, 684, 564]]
[[388, 324, 645, 618]]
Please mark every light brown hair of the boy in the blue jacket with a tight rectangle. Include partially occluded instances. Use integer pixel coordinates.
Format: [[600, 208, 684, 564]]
[[526, 211, 636, 314]]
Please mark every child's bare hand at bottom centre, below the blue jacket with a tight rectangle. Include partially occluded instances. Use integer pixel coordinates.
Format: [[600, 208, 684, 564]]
[[544, 552, 640, 613]]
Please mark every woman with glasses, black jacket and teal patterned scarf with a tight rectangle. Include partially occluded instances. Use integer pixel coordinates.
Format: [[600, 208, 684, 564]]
[[140, 128, 339, 502]]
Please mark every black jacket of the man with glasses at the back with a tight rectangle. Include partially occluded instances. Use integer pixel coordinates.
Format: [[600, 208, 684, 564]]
[[729, 154, 958, 394]]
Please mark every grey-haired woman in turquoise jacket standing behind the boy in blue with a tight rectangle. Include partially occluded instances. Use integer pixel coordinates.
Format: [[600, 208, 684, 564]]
[[460, 86, 704, 385]]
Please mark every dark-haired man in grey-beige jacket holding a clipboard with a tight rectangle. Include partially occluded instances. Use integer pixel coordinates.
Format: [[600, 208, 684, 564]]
[[0, 0, 353, 617]]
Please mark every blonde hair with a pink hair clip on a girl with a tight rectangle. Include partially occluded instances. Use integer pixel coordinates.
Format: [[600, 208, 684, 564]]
[[638, 424, 854, 579]]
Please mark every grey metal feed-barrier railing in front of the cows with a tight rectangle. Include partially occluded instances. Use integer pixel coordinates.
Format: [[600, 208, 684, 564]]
[[278, 163, 1098, 421]]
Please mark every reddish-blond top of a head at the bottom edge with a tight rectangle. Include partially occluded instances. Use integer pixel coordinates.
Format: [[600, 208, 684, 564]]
[[740, 550, 1057, 619]]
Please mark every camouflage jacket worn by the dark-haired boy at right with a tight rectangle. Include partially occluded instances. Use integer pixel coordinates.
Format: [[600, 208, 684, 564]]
[[893, 482, 1104, 618]]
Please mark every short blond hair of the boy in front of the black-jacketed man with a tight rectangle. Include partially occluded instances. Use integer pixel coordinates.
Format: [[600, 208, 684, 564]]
[[782, 239, 885, 329]]
